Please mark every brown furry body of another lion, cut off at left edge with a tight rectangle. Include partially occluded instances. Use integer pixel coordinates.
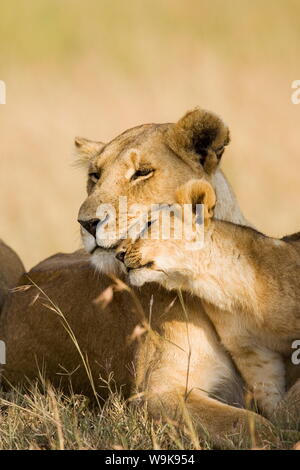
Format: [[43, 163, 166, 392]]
[[0, 240, 25, 312]]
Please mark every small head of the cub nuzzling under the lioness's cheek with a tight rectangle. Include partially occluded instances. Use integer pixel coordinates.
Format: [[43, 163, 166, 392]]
[[116, 180, 216, 290]]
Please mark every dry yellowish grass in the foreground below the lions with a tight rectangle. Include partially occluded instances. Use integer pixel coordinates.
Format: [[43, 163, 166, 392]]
[[0, 381, 300, 450]]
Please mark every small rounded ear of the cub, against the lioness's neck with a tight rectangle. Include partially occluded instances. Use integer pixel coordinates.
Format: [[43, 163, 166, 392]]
[[176, 180, 217, 225]]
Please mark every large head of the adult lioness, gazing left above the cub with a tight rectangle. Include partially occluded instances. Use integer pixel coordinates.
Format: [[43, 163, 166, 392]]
[[75, 109, 239, 272]]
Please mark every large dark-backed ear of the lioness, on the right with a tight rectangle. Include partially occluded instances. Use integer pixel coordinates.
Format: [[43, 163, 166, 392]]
[[166, 108, 230, 174]]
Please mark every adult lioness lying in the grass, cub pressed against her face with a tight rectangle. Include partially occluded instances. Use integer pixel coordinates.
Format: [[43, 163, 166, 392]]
[[0, 110, 276, 441]]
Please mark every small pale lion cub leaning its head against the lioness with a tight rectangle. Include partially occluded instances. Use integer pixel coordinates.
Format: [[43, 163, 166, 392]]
[[117, 180, 300, 417]]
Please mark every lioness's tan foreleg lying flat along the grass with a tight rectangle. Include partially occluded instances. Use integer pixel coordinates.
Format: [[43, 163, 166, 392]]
[[146, 389, 277, 447]]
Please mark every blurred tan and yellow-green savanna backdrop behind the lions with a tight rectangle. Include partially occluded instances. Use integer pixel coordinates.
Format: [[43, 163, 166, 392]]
[[0, 0, 300, 269]]
